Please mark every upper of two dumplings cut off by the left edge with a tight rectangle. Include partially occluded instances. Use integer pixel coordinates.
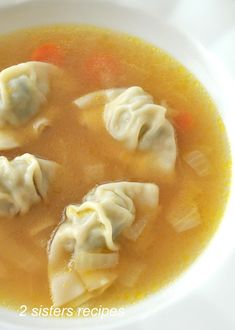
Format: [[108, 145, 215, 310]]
[[0, 62, 59, 150]]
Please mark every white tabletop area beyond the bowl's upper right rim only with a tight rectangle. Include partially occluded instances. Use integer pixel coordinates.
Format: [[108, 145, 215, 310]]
[[127, 0, 235, 77]]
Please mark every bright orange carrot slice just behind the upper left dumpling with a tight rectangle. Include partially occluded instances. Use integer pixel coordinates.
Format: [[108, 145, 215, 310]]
[[31, 43, 64, 66]]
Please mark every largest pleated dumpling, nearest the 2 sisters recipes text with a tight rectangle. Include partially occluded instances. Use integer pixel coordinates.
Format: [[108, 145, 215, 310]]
[[49, 182, 159, 306]]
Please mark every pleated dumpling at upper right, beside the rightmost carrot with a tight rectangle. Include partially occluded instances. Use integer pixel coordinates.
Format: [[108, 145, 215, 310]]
[[75, 86, 177, 174]]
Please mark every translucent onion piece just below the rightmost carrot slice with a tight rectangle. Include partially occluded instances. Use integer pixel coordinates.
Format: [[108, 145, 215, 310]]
[[183, 150, 210, 177]]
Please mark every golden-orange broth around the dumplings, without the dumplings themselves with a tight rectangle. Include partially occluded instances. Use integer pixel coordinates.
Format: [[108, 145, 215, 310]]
[[0, 26, 230, 309]]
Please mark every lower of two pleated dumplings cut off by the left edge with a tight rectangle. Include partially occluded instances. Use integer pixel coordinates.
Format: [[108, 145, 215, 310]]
[[0, 154, 58, 216]]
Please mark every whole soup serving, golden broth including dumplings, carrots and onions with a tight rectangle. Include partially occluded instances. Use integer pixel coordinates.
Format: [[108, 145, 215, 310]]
[[0, 25, 231, 311]]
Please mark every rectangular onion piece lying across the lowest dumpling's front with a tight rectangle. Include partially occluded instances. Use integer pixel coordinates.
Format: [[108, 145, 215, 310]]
[[73, 251, 119, 271]]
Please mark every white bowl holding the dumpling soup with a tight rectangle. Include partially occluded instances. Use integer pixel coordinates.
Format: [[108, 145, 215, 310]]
[[0, 0, 235, 329]]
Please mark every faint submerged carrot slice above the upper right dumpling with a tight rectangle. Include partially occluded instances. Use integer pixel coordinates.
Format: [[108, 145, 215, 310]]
[[84, 53, 120, 83]]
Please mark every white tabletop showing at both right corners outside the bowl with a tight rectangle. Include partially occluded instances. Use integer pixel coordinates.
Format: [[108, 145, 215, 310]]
[[0, 0, 235, 330]]
